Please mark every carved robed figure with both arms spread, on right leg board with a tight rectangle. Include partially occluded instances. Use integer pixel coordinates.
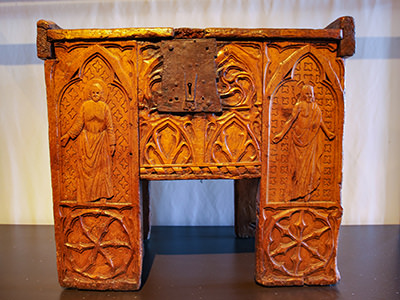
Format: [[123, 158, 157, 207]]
[[272, 85, 335, 201]]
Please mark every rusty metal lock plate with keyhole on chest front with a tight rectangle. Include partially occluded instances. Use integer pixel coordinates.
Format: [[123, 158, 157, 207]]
[[157, 39, 222, 113]]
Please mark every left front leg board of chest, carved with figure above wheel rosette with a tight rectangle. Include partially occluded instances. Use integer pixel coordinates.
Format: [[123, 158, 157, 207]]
[[46, 42, 142, 289]]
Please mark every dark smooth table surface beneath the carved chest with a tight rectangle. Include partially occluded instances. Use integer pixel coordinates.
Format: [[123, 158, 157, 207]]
[[0, 225, 400, 300]]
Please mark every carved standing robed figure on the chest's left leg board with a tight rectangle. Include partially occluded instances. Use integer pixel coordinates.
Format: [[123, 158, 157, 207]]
[[61, 80, 115, 203]]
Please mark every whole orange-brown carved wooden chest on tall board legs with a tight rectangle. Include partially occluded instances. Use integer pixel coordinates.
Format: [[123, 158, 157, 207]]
[[37, 17, 354, 290]]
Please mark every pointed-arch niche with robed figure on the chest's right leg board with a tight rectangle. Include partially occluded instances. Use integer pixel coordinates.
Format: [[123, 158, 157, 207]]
[[268, 46, 343, 202]]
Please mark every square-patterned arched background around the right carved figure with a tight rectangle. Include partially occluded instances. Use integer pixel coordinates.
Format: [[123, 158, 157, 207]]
[[268, 46, 341, 201]]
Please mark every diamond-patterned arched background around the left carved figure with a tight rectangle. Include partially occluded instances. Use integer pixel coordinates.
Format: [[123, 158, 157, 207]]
[[59, 46, 132, 203]]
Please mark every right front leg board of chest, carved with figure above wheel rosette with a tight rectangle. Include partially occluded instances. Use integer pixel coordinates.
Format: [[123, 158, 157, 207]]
[[256, 43, 344, 285]]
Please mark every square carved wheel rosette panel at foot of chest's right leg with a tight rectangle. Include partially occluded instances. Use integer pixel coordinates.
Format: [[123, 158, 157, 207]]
[[258, 203, 342, 285]]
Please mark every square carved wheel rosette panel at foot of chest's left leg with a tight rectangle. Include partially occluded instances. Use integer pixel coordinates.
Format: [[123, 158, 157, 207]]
[[60, 205, 140, 289]]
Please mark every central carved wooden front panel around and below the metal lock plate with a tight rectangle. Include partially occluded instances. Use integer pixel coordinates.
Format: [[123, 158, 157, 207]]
[[138, 42, 262, 180]]
